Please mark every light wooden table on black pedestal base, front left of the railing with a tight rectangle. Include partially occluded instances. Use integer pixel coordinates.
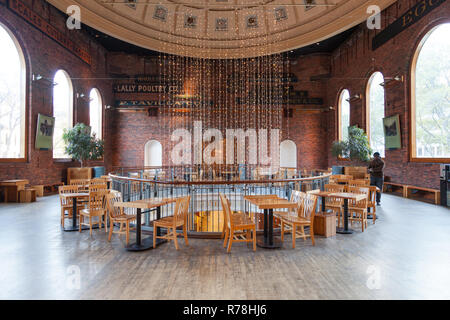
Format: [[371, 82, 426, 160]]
[[111, 198, 177, 251]]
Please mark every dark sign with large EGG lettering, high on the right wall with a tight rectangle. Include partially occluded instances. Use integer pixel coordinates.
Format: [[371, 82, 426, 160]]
[[372, 0, 446, 51]]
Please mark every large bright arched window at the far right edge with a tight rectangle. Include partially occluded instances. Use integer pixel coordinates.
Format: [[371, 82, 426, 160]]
[[411, 23, 450, 162]]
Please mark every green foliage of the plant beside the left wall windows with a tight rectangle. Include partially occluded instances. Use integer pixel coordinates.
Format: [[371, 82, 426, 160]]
[[63, 123, 104, 167]]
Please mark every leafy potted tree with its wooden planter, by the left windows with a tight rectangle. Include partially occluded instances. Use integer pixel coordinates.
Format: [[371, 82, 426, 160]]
[[63, 123, 104, 183]]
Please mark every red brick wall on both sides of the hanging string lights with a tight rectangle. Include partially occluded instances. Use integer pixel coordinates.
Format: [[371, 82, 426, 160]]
[[0, 0, 450, 187]]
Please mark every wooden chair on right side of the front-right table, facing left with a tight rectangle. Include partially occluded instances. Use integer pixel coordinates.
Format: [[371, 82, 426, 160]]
[[281, 193, 318, 248]]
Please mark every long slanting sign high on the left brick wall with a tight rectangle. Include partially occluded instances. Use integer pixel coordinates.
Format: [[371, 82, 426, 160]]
[[8, 0, 91, 65]]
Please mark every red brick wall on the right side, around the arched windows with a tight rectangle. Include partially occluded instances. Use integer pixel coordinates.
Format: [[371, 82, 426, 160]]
[[327, 0, 450, 188]]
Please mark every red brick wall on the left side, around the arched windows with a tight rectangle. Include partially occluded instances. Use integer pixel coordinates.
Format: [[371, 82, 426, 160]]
[[0, 0, 112, 184]]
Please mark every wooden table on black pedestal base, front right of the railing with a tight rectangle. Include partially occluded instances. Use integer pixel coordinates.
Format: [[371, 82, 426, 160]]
[[244, 195, 298, 249]]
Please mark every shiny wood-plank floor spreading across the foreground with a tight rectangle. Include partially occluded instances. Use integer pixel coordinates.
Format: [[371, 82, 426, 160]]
[[0, 195, 450, 299]]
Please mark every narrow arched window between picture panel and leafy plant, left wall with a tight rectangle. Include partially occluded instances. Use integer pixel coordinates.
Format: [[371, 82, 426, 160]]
[[53, 70, 73, 159]]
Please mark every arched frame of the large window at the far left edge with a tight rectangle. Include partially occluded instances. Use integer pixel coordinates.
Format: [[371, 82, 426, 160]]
[[0, 19, 30, 163]]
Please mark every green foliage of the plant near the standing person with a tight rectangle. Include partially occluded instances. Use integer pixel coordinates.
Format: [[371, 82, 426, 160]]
[[331, 126, 372, 162]]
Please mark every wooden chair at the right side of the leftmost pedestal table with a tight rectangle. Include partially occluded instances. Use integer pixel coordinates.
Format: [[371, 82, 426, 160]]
[[79, 187, 108, 236]]
